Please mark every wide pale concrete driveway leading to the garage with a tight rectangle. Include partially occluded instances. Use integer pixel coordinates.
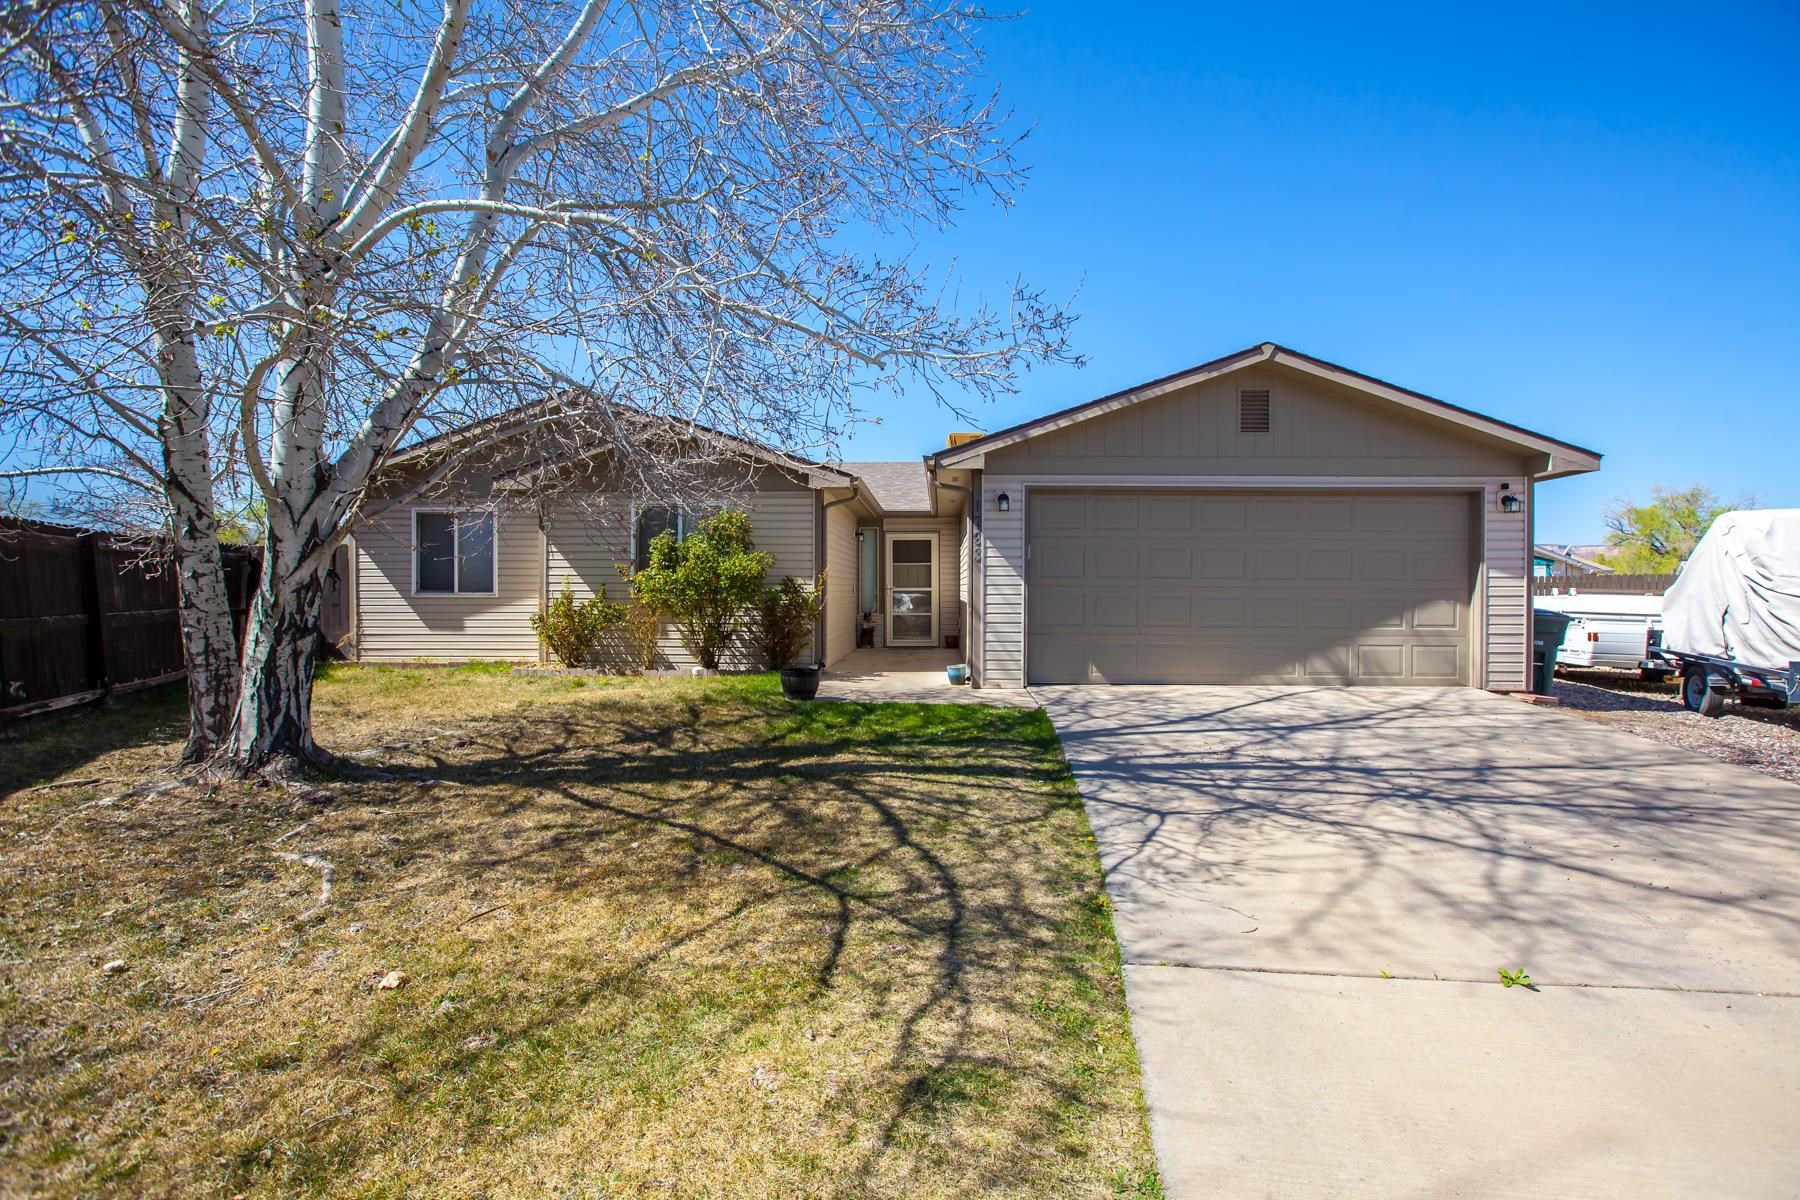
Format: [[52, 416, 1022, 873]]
[[1035, 687, 1800, 1200]]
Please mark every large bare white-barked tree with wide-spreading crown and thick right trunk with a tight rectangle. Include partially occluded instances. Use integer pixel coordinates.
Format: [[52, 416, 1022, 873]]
[[0, 0, 1069, 770]]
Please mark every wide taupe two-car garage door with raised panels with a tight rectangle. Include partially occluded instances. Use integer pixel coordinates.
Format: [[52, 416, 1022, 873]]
[[1026, 491, 1474, 685]]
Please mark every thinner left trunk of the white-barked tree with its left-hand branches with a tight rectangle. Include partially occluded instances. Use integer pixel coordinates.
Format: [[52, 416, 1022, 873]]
[[0, 4, 250, 761]]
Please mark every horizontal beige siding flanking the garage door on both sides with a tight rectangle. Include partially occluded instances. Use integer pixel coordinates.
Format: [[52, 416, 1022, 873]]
[[977, 470, 1530, 691]]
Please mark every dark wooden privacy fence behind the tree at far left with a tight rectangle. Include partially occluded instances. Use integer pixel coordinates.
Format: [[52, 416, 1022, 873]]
[[0, 522, 261, 721]]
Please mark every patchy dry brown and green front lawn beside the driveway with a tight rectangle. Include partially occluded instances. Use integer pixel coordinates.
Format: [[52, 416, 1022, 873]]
[[0, 669, 1159, 1198]]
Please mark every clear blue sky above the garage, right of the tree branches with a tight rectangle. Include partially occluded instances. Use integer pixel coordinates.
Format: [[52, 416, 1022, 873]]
[[844, 0, 1800, 542]]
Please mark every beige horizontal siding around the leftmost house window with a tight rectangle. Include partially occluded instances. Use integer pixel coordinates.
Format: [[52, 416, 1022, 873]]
[[355, 502, 542, 662]]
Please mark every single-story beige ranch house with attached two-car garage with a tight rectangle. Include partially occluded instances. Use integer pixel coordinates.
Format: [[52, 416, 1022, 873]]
[[346, 344, 1600, 691]]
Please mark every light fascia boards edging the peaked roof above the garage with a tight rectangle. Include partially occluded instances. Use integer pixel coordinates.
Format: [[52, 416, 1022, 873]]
[[931, 342, 1600, 479]]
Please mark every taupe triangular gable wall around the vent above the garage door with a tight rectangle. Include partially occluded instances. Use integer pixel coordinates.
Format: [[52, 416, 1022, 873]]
[[985, 365, 1519, 479]]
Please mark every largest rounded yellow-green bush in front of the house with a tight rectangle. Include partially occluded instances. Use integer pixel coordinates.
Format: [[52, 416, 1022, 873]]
[[632, 511, 774, 669]]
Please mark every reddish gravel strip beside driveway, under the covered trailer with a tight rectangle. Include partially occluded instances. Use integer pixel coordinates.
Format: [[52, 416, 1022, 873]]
[[1555, 669, 1800, 783]]
